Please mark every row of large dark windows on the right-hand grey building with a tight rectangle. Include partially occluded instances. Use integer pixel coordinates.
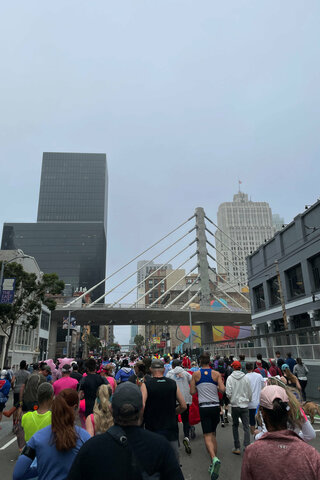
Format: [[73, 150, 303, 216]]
[[253, 254, 320, 311]]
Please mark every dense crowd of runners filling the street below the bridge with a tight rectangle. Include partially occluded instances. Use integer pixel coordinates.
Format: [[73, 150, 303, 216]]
[[0, 352, 320, 480]]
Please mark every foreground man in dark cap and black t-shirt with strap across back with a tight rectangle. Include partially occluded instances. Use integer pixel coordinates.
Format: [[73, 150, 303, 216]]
[[67, 382, 184, 480]]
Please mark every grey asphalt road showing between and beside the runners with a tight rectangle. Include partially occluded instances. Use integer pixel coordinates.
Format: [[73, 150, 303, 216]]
[[0, 417, 320, 480]]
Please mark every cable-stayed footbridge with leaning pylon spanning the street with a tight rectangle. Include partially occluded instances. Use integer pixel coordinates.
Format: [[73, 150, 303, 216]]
[[52, 208, 251, 341]]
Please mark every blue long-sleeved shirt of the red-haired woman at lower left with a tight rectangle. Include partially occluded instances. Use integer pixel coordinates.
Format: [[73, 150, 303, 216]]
[[13, 425, 91, 480]]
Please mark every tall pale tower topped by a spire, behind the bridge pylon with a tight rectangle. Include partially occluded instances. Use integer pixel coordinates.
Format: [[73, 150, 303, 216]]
[[216, 190, 275, 285]]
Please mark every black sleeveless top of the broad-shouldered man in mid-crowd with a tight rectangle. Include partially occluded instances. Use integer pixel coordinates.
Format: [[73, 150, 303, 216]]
[[144, 377, 178, 441]]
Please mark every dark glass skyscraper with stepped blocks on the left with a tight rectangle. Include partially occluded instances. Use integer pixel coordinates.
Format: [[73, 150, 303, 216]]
[[1, 153, 108, 299]]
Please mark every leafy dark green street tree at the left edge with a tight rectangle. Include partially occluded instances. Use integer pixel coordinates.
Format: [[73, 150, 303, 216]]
[[0, 262, 64, 363]]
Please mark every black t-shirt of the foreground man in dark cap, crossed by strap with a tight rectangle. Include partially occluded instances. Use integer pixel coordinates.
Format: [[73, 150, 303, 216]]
[[67, 427, 184, 480]]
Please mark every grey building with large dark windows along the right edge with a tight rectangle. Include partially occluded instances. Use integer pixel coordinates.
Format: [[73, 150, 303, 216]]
[[247, 201, 320, 398]]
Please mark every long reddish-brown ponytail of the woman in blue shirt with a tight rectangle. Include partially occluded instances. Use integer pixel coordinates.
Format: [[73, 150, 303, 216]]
[[51, 388, 79, 452]]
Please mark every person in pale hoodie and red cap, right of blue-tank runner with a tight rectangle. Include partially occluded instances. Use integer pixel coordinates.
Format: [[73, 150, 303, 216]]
[[226, 360, 252, 455]]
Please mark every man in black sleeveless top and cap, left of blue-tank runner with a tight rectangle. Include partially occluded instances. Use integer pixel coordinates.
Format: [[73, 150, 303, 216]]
[[141, 360, 187, 461]]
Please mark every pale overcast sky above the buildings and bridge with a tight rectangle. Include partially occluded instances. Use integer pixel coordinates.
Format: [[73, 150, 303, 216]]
[[0, 0, 320, 343]]
